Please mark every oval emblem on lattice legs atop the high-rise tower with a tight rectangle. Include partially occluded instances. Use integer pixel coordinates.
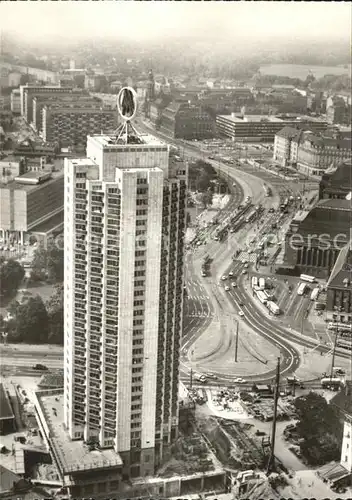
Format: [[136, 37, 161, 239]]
[[115, 87, 139, 144]]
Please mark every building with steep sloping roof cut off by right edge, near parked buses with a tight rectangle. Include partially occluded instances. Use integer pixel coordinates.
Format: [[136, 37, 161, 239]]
[[326, 241, 352, 323]]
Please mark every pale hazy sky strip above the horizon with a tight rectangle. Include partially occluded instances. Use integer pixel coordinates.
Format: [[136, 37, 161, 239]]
[[0, 1, 352, 41]]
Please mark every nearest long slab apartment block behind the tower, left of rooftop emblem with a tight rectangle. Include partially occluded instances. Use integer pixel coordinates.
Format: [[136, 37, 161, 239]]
[[42, 103, 117, 148]]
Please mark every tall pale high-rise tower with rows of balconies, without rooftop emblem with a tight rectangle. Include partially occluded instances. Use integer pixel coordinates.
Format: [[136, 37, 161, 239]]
[[65, 89, 187, 477]]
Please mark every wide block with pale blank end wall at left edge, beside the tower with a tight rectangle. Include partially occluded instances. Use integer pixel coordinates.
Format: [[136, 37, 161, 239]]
[[0, 170, 64, 244]]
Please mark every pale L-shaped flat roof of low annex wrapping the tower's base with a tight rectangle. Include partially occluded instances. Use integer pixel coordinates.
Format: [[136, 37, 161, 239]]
[[36, 389, 123, 474]]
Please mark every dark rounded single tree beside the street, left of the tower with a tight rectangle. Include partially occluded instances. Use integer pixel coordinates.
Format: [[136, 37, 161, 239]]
[[10, 295, 49, 344]]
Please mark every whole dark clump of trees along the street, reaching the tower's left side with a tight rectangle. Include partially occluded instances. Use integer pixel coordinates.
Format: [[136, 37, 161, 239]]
[[3, 285, 64, 345]]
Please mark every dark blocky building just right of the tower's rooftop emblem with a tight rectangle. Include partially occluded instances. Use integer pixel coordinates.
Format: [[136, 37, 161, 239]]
[[160, 102, 215, 140]]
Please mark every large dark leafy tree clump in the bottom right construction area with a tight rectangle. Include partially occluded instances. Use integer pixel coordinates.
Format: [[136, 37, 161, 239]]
[[294, 392, 343, 465]]
